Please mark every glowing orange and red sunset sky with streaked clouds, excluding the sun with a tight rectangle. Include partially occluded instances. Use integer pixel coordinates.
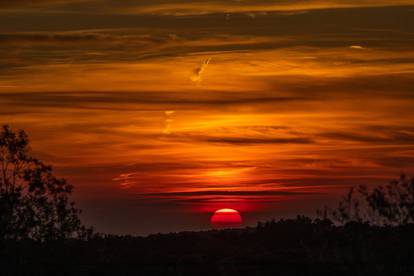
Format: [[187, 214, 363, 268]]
[[0, 0, 414, 234]]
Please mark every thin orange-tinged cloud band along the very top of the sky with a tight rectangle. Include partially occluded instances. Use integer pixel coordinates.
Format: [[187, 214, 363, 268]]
[[4, 0, 412, 15]]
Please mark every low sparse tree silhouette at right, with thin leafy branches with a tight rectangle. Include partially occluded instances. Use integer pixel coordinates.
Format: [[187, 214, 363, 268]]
[[326, 175, 414, 226]]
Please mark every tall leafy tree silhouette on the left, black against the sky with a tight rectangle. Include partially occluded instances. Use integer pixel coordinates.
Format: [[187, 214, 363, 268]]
[[0, 125, 92, 241]]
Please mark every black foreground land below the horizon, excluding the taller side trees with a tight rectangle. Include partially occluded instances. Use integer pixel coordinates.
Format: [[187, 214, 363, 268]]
[[0, 217, 414, 275]]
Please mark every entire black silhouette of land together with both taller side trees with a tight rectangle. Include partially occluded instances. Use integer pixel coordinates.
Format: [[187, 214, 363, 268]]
[[0, 126, 414, 275]]
